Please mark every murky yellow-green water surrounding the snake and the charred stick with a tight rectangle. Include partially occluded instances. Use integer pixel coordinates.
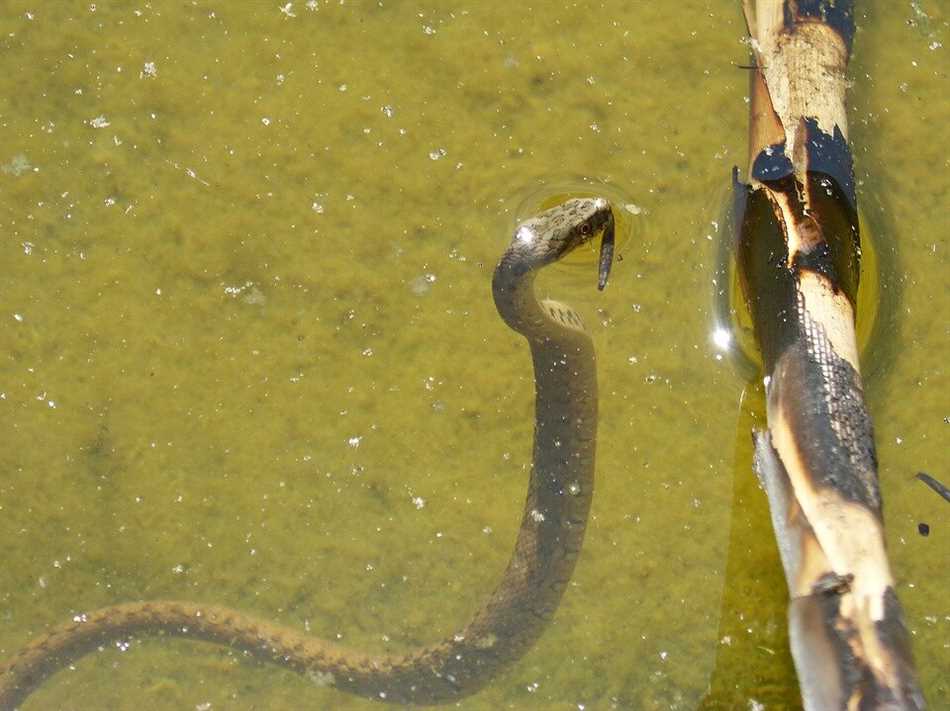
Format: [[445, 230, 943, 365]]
[[0, 0, 950, 711]]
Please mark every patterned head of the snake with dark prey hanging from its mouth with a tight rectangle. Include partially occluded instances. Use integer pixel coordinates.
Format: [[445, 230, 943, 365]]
[[513, 197, 614, 289]]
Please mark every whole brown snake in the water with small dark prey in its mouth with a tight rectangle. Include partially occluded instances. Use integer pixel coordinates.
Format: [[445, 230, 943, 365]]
[[0, 197, 615, 711]]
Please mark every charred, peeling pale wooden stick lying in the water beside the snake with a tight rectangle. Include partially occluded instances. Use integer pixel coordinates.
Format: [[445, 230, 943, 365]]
[[736, 0, 924, 711]]
